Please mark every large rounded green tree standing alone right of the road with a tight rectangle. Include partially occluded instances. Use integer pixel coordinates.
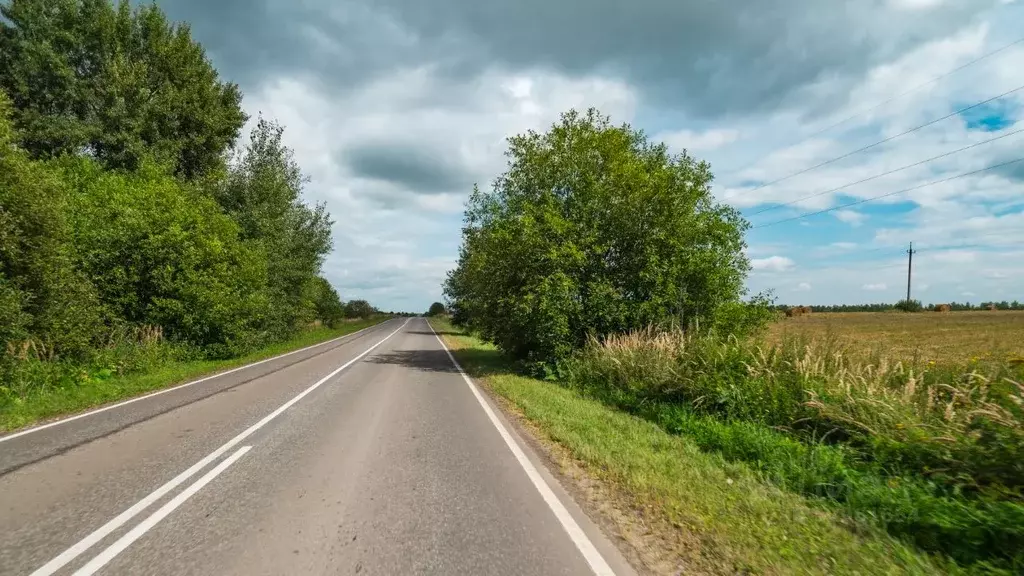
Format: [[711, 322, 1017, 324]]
[[444, 110, 750, 364]]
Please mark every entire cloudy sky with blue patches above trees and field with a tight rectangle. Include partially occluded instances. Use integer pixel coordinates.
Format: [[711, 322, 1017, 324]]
[[158, 0, 1024, 312]]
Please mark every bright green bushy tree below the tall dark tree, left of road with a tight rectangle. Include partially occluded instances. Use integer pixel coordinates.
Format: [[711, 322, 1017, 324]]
[[60, 158, 273, 357]]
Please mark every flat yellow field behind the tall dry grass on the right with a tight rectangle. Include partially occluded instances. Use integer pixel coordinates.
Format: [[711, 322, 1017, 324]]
[[769, 311, 1024, 362]]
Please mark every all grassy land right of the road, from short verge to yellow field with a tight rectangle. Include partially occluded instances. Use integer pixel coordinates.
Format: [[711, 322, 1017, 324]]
[[438, 312, 1024, 574]]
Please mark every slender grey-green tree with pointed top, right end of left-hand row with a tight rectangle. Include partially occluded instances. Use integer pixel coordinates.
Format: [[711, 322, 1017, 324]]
[[211, 118, 332, 336]]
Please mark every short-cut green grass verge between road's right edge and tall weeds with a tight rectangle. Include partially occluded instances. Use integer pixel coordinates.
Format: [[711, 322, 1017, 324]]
[[431, 319, 961, 574]]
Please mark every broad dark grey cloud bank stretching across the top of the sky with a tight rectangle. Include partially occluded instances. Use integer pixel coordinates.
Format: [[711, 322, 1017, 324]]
[[155, 0, 997, 117]]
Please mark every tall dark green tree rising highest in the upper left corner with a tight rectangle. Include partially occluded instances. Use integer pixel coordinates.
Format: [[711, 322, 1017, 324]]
[[0, 0, 246, 178]]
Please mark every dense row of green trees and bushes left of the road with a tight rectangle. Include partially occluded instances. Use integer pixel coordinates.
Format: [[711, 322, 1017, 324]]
[[0, 0, 376, 385]]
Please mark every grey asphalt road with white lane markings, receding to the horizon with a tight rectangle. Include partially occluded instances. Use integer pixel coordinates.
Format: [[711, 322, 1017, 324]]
[[0, 319, 632, 575]]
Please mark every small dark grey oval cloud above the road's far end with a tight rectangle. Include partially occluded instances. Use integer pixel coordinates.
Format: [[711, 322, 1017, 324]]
[[341, 143, 472, 194]]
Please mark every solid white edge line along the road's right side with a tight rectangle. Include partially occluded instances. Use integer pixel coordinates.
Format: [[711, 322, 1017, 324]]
[[426, 321, 615, 576]]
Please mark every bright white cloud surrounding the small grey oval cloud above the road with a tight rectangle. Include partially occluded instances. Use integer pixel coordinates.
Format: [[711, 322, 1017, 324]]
[[244, 69, 636, 312]]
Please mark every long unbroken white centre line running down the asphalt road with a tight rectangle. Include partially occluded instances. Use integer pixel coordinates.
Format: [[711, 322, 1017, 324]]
[[32, 320, 409, 576]]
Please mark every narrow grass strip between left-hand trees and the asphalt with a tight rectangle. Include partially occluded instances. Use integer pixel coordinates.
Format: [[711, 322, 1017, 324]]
[[0, 317, 387, 433]]
